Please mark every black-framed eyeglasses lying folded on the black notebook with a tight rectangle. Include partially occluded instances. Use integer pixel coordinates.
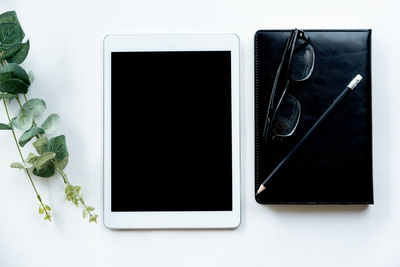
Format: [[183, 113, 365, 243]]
[[263, 29, 315, 141]]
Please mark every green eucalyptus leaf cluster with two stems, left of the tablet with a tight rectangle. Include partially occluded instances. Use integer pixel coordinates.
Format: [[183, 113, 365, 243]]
[[0, 11, 98, 222]]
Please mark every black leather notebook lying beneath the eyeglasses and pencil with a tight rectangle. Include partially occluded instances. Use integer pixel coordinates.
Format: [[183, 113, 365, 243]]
[[255, 30, 374, 204]]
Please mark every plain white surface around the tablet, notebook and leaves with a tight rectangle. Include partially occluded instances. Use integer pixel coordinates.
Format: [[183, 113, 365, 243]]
[[0, 0, 400, 267]]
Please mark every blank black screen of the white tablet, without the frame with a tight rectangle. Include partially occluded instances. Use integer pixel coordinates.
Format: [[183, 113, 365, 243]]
[[111, 51, 232, 211]]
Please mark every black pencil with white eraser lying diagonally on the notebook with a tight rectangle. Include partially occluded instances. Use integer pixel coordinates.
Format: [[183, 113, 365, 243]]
[[256, 74, 362, 195]]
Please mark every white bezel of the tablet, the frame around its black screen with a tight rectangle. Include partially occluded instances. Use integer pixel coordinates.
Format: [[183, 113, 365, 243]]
[[103, 34, 241, 229]]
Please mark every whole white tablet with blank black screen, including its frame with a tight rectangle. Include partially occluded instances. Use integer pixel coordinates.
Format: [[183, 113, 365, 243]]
[[104, 34, 241, 229]]
